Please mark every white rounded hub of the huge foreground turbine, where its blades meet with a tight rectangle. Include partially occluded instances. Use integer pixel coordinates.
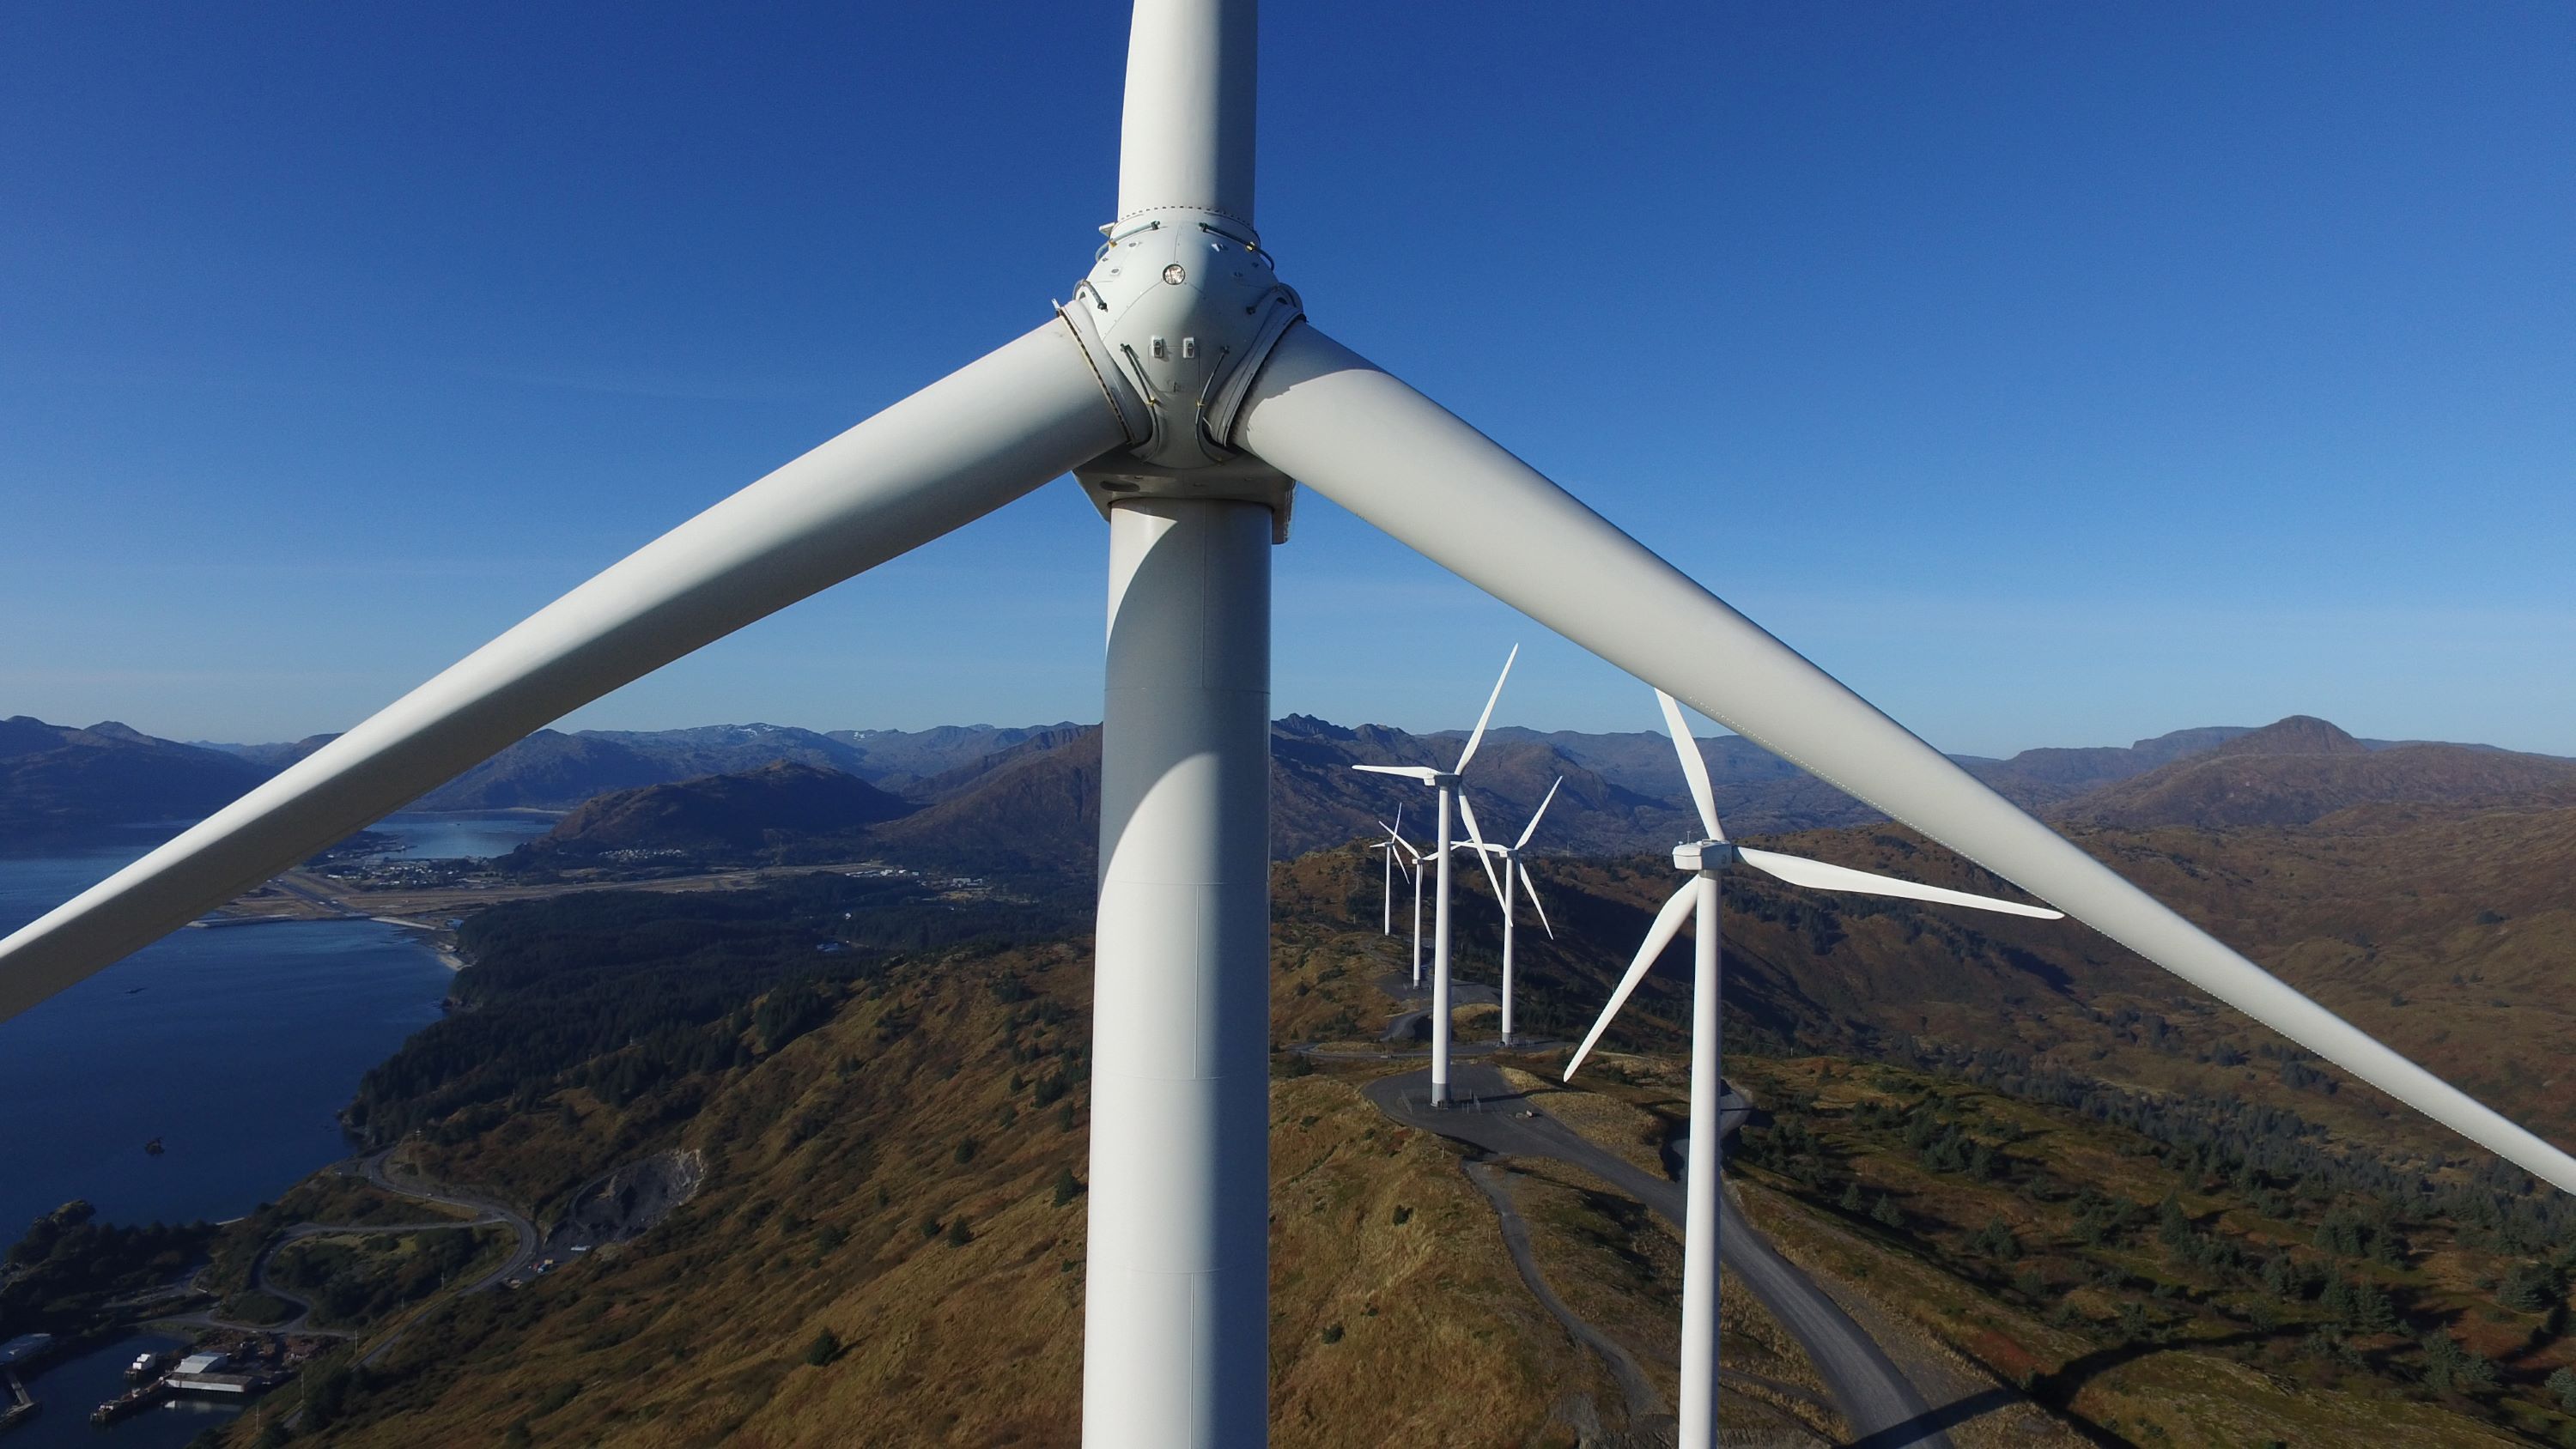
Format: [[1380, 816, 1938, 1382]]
[[1061, 209, 1303, 473]]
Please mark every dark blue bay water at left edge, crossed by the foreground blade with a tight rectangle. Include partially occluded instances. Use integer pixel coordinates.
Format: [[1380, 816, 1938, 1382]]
[[0, 834, 451, 1246]]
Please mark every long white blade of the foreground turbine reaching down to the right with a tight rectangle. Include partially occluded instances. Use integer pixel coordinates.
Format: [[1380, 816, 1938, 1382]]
[[1231, 324, 2576, 1191]]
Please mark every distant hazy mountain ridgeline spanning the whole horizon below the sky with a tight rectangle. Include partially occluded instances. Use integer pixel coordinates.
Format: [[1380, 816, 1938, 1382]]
[[0, 716, 2576, 872]]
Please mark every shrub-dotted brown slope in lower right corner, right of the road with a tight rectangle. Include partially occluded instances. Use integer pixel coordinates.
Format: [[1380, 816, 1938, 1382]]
[[1731, 1058, 2576, 1446]]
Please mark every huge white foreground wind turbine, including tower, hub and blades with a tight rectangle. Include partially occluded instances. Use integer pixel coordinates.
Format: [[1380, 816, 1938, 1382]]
[[15, 0, 2576, 1449]]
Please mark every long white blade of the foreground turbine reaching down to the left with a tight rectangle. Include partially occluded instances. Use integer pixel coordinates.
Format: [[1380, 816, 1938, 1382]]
[[0, 322, 1126, 1022]]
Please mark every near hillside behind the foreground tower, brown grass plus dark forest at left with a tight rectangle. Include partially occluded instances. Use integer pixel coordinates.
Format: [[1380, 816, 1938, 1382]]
[[216, 867, 1811, 1449]]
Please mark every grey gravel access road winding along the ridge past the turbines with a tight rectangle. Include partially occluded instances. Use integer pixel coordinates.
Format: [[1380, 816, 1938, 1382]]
[[1368, 1060, 1950, 1449]]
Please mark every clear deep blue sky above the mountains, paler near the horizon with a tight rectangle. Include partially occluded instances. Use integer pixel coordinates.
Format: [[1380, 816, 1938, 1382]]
[[0, 0, 2576, 754]]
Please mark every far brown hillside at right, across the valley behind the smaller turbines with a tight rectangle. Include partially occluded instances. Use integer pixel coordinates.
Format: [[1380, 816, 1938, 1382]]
[[1494, 808, 2576, 1179]]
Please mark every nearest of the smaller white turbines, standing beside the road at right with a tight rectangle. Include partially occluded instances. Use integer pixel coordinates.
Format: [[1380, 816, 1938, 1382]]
[[1566, 690, 2063, 1449]]
